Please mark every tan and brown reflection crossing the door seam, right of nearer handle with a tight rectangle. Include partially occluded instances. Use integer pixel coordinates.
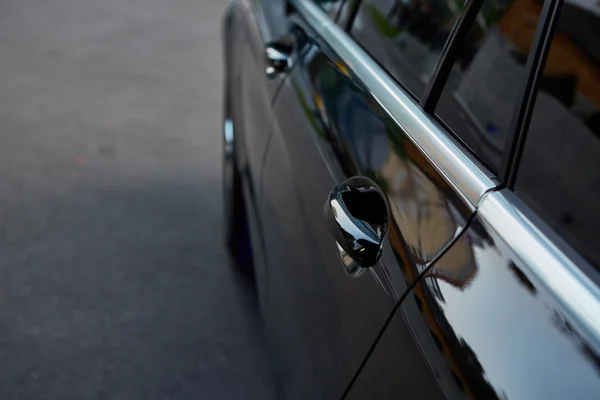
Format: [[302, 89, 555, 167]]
[[379, 139, 490, 398]]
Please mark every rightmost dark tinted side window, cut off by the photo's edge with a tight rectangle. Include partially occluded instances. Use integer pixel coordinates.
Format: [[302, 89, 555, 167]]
[[515, 2, 600, 269]]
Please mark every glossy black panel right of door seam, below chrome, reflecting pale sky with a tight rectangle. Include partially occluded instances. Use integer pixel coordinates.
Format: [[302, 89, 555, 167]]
[[349, 208, 600, 399]]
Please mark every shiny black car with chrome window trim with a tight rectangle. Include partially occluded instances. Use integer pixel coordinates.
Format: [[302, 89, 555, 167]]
[[223, 0, 600, 399]]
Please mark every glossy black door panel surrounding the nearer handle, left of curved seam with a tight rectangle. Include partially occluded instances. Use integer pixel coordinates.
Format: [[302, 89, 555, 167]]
[[256, 10, 472, 399]]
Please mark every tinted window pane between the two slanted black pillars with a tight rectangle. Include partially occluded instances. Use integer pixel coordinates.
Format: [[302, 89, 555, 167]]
[[435, 0, 542, 173]]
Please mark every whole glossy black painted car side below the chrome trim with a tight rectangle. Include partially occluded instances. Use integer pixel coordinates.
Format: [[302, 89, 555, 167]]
[[225, 0, 600, 399]]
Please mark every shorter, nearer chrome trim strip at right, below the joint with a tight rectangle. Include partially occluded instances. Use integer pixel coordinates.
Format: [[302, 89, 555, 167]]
[[477, 190, 600, 348]]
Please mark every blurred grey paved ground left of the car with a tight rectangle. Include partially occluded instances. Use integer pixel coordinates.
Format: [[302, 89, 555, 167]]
[[0, 0, 273, 400]]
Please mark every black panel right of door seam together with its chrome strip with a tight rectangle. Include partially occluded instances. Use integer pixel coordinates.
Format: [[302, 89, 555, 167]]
[[348, 190, 600, 399]]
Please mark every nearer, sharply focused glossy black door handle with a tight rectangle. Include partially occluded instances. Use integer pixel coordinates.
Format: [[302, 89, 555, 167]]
[[324, 177, 388, 275]]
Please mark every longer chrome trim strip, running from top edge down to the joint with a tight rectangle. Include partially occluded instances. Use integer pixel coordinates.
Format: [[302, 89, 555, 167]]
[[290, 0, 496, 210]]
